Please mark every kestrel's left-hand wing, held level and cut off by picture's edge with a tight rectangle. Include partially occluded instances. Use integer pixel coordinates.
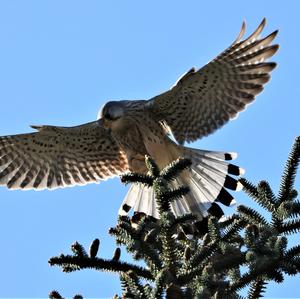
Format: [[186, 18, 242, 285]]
[[0, 120, 128, 189]]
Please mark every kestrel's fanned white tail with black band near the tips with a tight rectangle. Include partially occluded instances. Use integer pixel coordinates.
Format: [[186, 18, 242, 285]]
[[119, 147, 244, 220]]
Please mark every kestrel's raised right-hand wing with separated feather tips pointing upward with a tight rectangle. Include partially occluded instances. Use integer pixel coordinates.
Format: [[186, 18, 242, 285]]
[[147, 19, 278, 143]]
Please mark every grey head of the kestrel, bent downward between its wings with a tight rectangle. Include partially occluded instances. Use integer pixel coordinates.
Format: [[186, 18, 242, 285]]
[[98, 101, 125, 129]]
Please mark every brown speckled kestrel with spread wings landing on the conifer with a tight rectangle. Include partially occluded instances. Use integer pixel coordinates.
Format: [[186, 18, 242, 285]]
[[0, 19, 278, 220]]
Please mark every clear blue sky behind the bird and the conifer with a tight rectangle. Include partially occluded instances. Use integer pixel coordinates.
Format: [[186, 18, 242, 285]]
[[0, 0, 300, 298]]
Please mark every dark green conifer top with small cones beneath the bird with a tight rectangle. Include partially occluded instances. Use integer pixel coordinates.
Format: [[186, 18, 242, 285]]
[[49, 137, 300, 299]]
